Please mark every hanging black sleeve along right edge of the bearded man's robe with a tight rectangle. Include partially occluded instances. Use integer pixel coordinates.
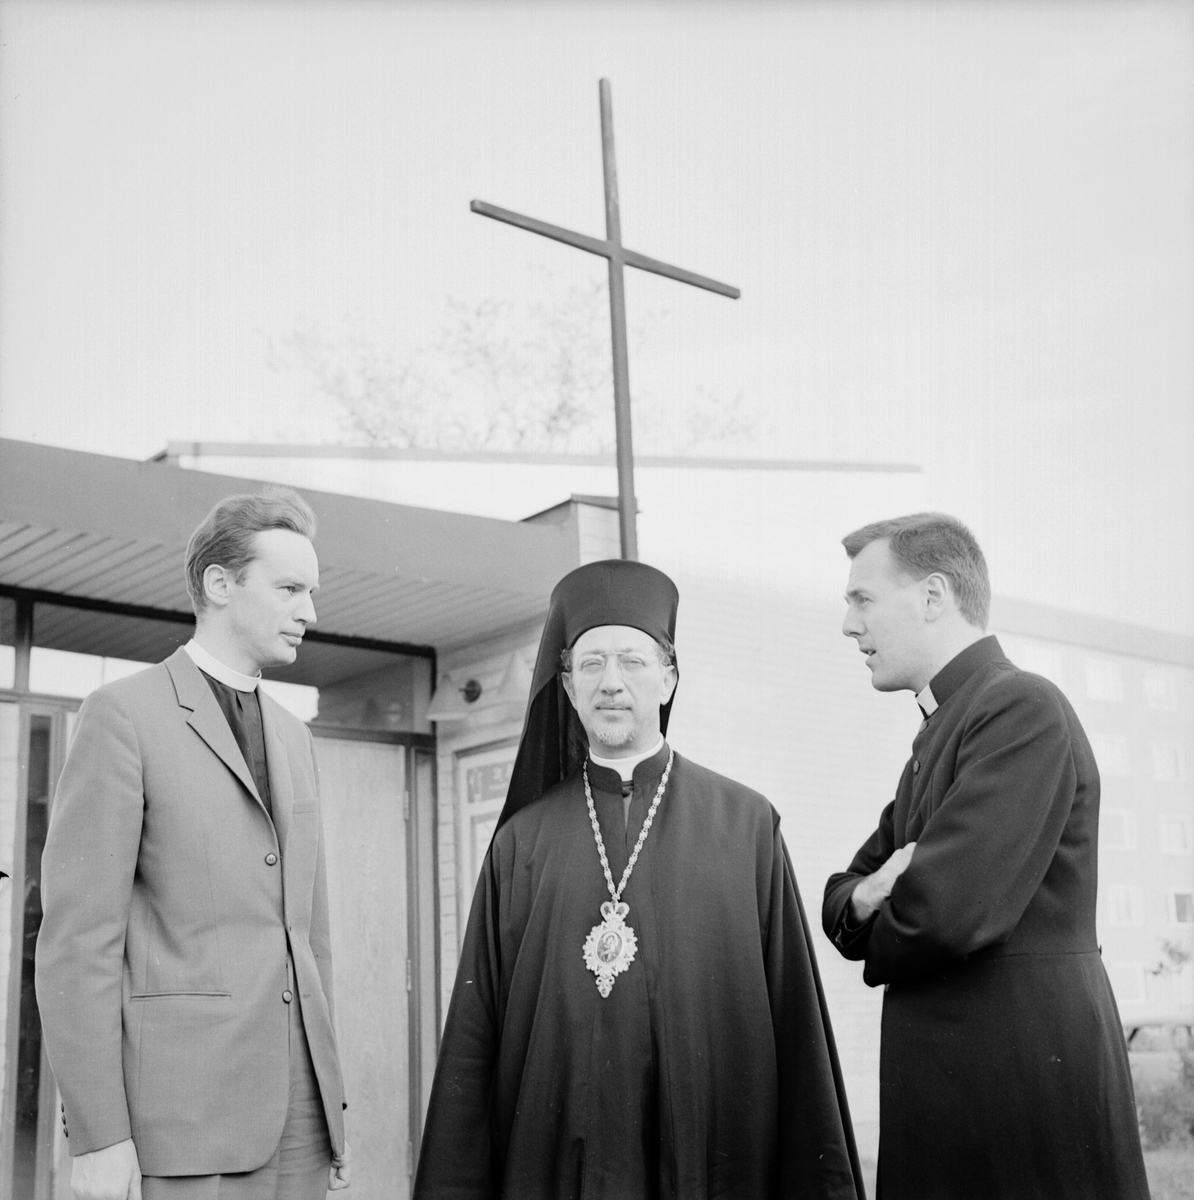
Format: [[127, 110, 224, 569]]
[[766, 823, 865, 1200]]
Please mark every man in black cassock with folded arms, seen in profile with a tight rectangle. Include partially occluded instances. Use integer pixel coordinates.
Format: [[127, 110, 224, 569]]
[[822, 512, 1148, 1200]]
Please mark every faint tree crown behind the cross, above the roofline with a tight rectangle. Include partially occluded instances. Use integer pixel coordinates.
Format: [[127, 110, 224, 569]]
[[281, 283, 754, 452]]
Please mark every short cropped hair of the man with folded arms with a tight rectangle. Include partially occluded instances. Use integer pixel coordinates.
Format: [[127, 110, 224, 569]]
[[841, 512, 991, 629]]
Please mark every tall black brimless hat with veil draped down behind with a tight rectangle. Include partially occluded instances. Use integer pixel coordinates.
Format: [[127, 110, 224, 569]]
[[498, 558, 679, 826]]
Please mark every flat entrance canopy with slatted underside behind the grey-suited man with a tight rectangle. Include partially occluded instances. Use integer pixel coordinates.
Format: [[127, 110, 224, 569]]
[[0, 439, 580, 674]]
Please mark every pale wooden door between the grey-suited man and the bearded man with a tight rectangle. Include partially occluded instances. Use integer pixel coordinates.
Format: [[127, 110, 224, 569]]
[[313, 727, 438, 1200]]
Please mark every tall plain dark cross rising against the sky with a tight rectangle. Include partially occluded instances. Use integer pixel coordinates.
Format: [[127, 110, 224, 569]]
[[469, 79, 742, 559]]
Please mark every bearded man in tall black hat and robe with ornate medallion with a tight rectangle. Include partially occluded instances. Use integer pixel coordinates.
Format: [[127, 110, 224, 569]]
[[415, 560, 863, 1200]]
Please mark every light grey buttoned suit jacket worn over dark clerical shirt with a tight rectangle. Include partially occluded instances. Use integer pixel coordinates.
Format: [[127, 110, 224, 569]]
[[37, 649, 344, 1175]]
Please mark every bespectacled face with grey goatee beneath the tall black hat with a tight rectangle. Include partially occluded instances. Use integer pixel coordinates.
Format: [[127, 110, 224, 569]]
[[563, 625, 676, 758]]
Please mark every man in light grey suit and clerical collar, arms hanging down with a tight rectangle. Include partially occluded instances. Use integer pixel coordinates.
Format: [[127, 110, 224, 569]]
[[37, 488, 348, 1200]]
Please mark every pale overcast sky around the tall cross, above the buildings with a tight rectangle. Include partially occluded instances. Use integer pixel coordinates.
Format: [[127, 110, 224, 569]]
[[0, 0, 1194, 634]]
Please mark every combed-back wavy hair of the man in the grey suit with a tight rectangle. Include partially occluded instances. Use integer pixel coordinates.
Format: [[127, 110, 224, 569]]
[[186, 485, 316, 617]]
